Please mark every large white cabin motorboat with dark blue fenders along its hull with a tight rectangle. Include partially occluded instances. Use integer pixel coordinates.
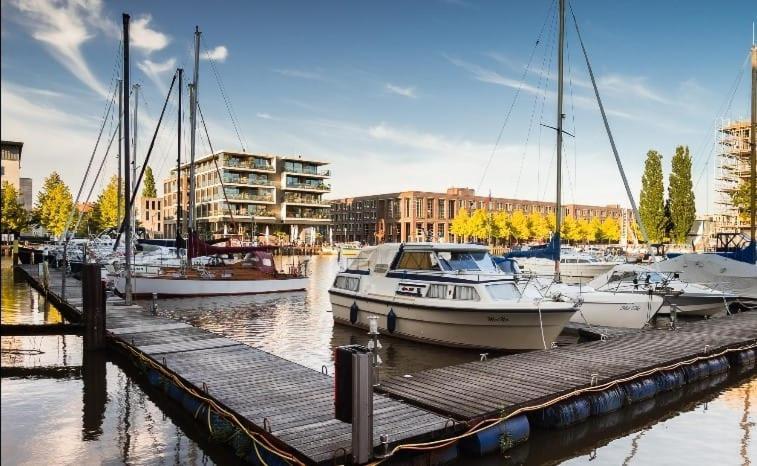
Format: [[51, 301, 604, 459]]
[[329, 243, 579, 350]]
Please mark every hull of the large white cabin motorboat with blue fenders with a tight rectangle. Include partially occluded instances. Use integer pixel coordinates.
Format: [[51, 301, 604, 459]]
[[330, 291, 575, 351]]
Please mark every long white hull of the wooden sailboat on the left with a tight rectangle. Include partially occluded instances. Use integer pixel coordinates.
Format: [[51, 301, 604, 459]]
[[115, 275, 308, 298]]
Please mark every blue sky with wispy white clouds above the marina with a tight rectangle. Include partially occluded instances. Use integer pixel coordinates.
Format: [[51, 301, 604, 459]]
[[0, 0, 757, 213]]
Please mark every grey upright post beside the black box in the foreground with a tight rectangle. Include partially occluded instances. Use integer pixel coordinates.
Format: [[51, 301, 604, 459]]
[[352, 353, 373, 464]]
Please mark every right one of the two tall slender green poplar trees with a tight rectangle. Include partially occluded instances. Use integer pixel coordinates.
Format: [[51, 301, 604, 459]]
[[668, 146, 696, 243]]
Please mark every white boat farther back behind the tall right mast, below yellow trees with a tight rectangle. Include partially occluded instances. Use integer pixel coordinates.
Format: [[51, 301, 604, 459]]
[[518, 246, 618, 284]]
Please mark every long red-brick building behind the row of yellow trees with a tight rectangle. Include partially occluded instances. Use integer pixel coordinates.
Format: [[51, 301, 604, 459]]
[[330, 188, 629, 244]]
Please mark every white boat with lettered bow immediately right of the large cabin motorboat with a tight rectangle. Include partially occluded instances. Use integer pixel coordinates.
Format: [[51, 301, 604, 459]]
[[494, 257, 663, 329]]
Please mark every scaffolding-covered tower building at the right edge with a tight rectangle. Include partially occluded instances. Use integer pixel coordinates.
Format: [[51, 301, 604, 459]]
[[715, 120, 751, 232]]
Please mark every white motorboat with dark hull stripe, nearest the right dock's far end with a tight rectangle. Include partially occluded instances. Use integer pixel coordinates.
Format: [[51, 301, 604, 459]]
[[588, 264, 735, 316]]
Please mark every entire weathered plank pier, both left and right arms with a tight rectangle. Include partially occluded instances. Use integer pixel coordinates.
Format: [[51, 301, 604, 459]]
[[11, 265, 757, 464]]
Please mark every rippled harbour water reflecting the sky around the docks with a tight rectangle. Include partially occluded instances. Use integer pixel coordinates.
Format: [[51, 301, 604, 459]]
[[0, 257, 757, 466]]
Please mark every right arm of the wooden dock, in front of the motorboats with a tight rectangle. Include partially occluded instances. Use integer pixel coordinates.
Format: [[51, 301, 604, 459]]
[[381, 312, 757, 422]]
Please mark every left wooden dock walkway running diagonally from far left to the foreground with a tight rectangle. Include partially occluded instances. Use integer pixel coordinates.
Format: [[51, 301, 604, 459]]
[[14, 265, 449, 464]]
